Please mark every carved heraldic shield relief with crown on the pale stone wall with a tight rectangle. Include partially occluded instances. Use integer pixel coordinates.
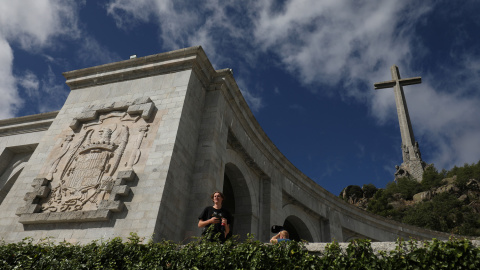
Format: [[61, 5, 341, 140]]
[[17, 98, 159, 224]]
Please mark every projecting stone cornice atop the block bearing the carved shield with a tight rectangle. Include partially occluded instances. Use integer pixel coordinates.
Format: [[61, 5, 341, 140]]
[[63, 46, 215, 90]]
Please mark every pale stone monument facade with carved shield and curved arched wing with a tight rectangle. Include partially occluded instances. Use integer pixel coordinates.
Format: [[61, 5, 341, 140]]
[[0, 47, 456, 243]]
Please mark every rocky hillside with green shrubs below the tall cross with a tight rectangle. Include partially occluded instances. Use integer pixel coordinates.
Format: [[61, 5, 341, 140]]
[[340, 162, 480, 236]]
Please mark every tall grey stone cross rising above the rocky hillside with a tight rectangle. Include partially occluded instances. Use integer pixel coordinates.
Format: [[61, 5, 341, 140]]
[[374, 65, 425, 181]]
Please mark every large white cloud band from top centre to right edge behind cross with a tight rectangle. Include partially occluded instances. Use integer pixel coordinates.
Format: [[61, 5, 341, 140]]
[[108, 0, 480, 171]]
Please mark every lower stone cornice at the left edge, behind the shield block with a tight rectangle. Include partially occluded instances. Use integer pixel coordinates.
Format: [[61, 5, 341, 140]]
[[0, 111, 58, 137]]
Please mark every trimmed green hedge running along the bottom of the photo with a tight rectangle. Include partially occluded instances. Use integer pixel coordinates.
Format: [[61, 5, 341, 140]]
[[0, 234, 480, 269]]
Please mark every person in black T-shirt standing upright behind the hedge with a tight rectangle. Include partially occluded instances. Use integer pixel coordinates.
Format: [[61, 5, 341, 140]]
[[198, 191, 232, 243]]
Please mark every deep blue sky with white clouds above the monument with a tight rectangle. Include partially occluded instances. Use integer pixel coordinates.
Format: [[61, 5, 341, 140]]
[[0, 0, 480, 195]]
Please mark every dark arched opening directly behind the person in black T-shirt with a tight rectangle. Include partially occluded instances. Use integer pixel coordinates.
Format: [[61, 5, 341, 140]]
[[223, 163, 253, 239]]
